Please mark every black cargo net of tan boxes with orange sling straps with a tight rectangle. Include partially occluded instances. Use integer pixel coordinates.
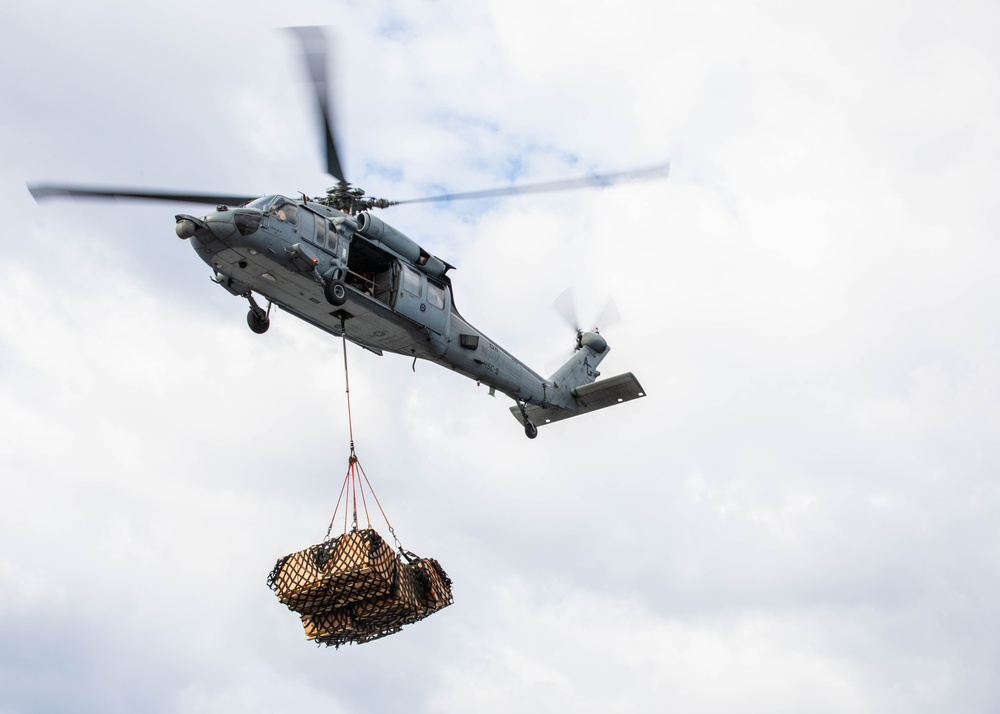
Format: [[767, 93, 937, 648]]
[[267, 442, 453, 647]]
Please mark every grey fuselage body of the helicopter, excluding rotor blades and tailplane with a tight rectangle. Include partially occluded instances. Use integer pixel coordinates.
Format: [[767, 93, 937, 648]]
[[176, 196, 584, 409]]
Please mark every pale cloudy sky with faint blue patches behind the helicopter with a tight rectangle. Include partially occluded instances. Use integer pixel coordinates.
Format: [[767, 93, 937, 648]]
[[0, 0, 1000, 714]]
